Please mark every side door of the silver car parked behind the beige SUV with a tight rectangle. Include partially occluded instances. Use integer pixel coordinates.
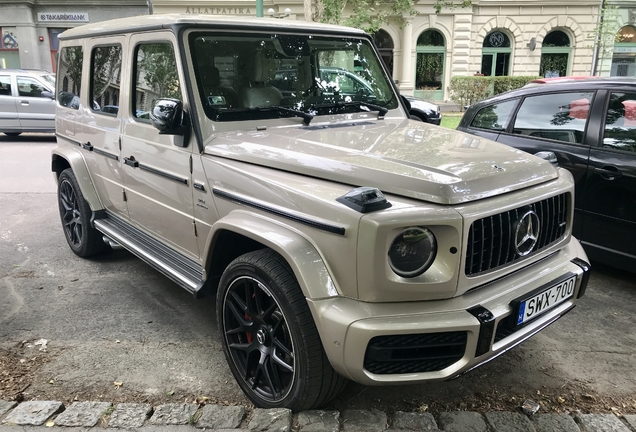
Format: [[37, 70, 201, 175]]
[[16, 75, 55, 131]]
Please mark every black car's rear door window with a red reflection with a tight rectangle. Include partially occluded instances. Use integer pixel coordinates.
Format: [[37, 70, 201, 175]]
[[513, 92, 594, 144]]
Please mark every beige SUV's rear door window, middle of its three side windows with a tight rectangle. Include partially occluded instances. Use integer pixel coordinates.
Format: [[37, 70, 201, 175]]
[[90, 45, 121, 116]]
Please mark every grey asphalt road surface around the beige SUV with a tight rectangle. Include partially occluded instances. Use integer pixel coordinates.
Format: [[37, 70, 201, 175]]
[[0, 134, 636, 412]]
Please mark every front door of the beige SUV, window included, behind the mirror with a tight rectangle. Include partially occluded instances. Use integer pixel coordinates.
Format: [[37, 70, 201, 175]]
[[121, 33, 199, 260]]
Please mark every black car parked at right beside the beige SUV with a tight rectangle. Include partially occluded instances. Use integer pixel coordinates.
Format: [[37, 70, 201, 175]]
[[457, 77, 636, 271]]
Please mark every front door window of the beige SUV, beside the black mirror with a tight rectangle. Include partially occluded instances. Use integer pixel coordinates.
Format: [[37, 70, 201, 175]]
[[133, 42, 182, 122]]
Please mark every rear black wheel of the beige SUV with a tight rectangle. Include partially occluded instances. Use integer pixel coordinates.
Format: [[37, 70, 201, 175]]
[[57, 168, 108, 258]]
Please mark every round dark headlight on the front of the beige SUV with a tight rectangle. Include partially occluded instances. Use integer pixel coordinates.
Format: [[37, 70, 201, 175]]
[[389, 227, 437, 278]]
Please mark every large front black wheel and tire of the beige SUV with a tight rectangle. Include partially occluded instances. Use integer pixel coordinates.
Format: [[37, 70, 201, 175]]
[[216, 249, 347, 411]]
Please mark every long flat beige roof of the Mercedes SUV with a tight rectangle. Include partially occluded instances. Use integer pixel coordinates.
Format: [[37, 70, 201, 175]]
[[59, 14, 365, 40]]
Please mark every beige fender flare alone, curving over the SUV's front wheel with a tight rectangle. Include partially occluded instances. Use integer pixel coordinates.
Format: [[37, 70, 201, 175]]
[[205, 210, 341, 300]]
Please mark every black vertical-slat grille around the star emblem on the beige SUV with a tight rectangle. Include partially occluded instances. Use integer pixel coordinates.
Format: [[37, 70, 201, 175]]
[[465, 193, 569, 276]]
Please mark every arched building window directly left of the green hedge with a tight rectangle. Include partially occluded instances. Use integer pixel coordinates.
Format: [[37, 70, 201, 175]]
[[415, 29, 446, 100]]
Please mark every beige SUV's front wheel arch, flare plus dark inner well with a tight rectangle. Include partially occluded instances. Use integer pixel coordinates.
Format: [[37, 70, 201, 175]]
[[205, 211, 339, 299]]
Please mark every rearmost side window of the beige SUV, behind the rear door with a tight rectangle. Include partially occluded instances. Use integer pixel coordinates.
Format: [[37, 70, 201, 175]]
[[56, 47, 84, 109]]
